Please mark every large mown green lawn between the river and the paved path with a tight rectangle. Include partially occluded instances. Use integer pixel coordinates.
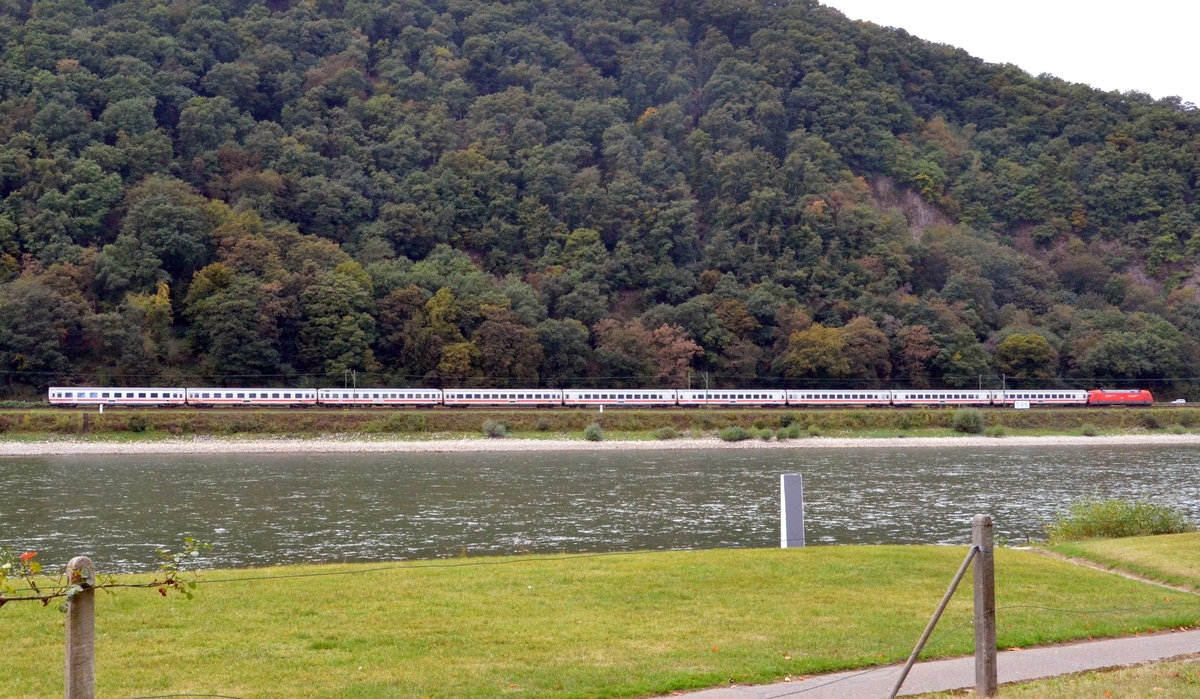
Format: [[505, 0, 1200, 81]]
[[0, 546, 1200, 697]]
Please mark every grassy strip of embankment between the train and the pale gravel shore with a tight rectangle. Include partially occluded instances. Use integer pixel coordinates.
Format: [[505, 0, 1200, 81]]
[[0, 407, 1200, 440]]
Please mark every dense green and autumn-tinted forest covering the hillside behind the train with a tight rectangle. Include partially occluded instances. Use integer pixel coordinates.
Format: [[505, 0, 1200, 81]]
[[0, 0, 1200, 399]]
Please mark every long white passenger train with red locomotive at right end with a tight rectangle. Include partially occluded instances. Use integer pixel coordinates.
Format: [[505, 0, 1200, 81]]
[[48, 387, 1154, 408]]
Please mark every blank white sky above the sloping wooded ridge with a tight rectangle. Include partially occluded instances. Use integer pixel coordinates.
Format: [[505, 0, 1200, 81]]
[[822, 0, 1200, 104]]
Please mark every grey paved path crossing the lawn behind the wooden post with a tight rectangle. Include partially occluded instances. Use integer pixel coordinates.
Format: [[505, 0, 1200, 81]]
[[686, 631, 1200, 699]]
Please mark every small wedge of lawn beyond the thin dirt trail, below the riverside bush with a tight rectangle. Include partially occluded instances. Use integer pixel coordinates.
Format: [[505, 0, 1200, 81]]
[[1046, 532, 1200, 591]]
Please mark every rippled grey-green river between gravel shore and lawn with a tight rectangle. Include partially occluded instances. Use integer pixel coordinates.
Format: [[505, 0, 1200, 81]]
[[0, 447, 1200, 570]]
